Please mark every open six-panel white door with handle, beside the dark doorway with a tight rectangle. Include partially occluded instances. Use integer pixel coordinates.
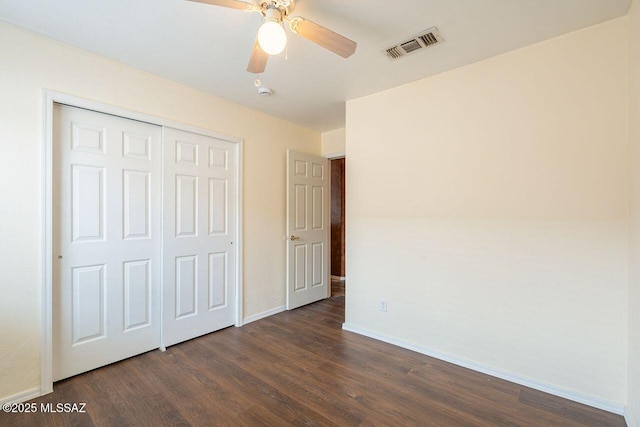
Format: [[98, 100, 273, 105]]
[[287, 150, 330, 310]]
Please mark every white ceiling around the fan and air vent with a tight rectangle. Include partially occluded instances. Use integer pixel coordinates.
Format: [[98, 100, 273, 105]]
[[0, 0, 632, 132]]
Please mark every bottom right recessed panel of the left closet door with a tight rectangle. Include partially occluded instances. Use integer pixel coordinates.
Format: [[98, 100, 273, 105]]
[[123, 259, 151, 331]]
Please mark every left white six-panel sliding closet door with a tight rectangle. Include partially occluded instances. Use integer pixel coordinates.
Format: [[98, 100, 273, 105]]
[[52, 105, 162, 381]]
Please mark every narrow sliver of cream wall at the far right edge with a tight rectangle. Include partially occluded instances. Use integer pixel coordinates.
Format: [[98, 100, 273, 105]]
[[627, 0, 640, 427]]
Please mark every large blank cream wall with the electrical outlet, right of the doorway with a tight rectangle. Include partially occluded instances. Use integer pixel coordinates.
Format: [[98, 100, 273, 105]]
[[345, 18, 629, 411]]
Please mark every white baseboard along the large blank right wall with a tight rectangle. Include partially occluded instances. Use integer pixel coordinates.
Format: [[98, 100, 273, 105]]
[[342, 323, 624, 418]]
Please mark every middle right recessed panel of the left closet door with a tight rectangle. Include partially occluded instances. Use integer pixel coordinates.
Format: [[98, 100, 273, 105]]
[[122, 170, 151, 239]]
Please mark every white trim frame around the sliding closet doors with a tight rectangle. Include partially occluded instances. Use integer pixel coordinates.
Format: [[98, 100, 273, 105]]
[[40, 89, 243, 397]]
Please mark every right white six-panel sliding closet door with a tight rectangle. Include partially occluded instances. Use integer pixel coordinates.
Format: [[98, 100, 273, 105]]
[[162, 128, 238, 346]]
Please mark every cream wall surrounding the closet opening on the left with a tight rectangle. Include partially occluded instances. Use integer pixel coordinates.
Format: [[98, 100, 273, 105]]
[[0, 23, 320, 400]]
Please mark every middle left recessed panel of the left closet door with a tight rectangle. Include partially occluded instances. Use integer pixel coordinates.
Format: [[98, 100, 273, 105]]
[[71, 165, 105, 242]]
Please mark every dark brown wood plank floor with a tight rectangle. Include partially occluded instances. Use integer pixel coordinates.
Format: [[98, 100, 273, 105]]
[[0, 284, 625, 426]]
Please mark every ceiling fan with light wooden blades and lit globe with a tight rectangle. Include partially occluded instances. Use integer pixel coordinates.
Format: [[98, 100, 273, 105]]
[[188, 0, 358, 74]]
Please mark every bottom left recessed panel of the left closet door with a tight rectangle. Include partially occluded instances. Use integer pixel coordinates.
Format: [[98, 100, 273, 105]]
[[71, 265, 106, 345]]
